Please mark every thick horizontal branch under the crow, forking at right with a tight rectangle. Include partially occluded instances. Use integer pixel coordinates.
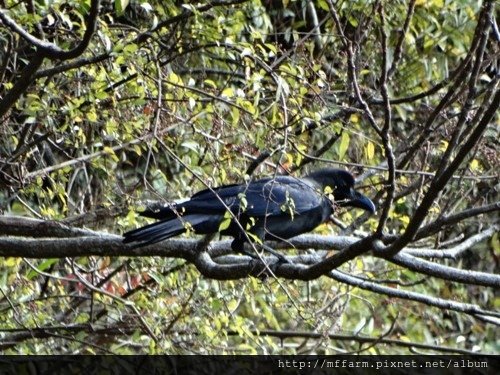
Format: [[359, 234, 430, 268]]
[[0, 217, 500, 287]]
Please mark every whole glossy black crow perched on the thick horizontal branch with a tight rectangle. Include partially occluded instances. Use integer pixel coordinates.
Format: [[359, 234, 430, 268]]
[[123, 169, 375, 252]]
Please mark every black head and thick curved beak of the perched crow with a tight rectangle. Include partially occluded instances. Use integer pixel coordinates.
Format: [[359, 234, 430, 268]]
[[307, 168, 375, 214]]
